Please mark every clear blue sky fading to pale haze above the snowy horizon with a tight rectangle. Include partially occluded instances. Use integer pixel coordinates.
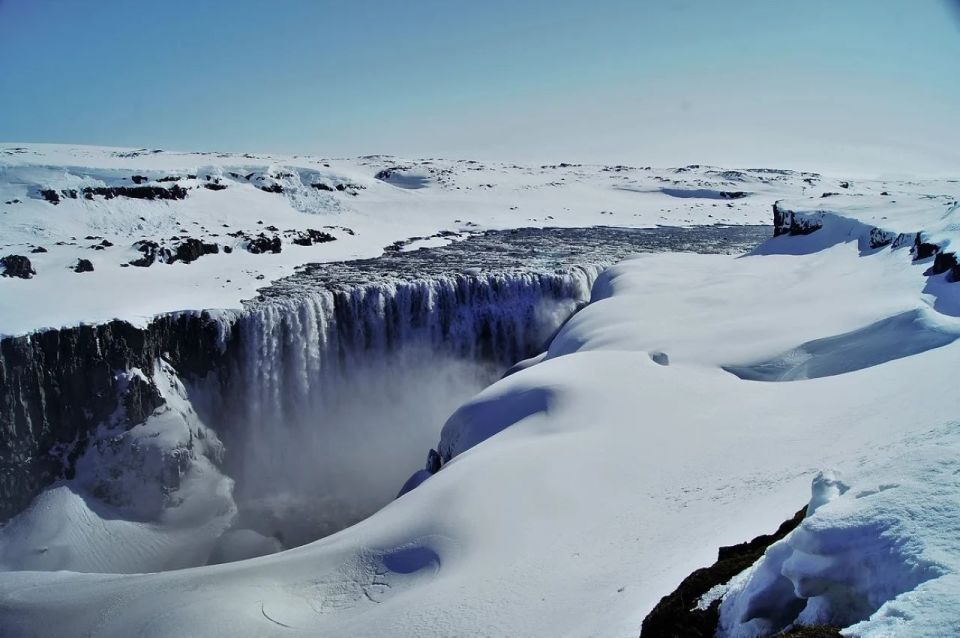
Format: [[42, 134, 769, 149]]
[[0, 0, 960, 174]]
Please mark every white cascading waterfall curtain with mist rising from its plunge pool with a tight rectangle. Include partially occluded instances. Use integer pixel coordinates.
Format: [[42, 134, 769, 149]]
[[194, 266, 599, 544]]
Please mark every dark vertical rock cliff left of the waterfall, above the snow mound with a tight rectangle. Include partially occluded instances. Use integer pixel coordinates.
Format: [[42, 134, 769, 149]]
[[0, 313, 229, 521]]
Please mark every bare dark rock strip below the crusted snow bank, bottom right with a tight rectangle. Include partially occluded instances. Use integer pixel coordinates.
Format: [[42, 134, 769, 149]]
[[640, 507, 806, 638]]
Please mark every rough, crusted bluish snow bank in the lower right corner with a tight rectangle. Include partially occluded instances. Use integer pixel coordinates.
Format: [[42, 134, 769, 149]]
[[717, 436, 960, 638]]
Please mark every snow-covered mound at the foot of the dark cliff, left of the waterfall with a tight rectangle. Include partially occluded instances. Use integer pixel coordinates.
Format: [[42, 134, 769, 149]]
[[0, 369, 236, 573]]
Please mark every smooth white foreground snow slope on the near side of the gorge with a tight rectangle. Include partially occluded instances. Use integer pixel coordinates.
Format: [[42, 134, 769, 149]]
[[0, 184, 960, 636]]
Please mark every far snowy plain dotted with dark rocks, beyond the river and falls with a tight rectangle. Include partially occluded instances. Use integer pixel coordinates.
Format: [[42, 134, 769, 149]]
[[0, 143, 946, 334]]
